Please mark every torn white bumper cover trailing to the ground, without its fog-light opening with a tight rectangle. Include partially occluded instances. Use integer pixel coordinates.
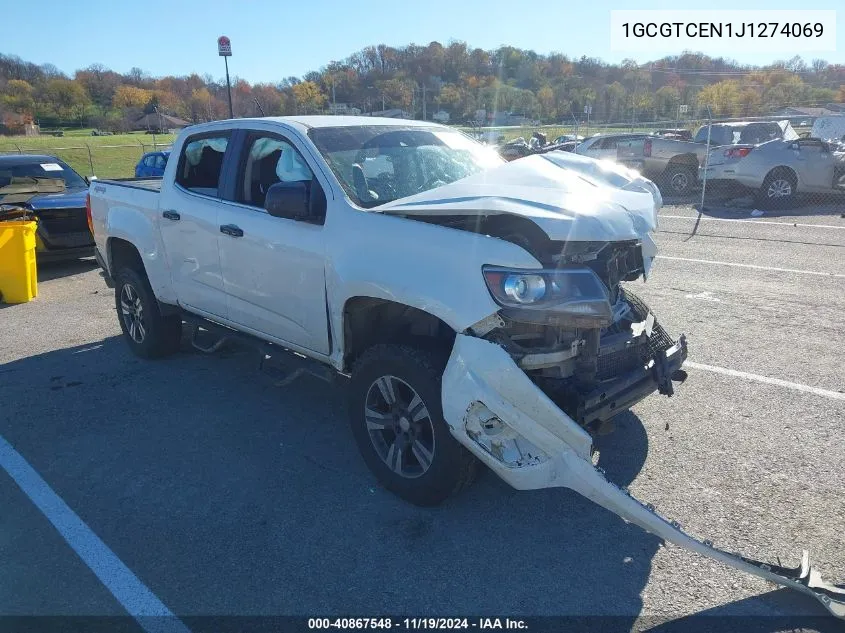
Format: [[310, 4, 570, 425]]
[[442, 334, 845, 617]]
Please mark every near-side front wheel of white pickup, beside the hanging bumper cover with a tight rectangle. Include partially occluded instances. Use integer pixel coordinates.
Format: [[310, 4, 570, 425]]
[[349, 345, 477, 506]]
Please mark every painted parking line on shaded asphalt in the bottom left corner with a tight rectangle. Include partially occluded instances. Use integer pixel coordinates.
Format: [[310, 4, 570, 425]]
[[0, 436, 189, 633]]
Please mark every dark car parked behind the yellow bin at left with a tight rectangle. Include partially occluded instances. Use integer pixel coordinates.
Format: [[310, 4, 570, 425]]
[[0, 154, 94, 260]]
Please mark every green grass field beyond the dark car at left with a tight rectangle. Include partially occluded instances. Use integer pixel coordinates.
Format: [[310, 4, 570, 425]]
[[0, 129, 176, 178]]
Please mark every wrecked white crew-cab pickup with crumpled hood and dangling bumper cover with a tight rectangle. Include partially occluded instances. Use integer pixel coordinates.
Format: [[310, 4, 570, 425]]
[[89, 117, 845, 612]]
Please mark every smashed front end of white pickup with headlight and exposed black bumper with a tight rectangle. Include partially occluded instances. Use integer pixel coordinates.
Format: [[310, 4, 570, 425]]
[[470, 241, 687, 430]]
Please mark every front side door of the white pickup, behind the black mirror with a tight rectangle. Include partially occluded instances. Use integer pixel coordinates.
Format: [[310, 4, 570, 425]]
[[217, 130, 330, 354]]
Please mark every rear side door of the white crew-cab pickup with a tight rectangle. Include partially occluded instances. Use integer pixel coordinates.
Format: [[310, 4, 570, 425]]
[[159, 131, 231, 318]]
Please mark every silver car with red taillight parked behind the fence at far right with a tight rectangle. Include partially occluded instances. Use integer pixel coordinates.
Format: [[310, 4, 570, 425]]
[[707, 138, 845, 206]]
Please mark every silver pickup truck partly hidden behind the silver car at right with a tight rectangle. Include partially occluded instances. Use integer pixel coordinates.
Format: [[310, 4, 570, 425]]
[[616, 121, 798, 196]]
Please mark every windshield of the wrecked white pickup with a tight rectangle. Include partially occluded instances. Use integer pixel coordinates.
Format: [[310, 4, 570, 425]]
[[308, 125, 504, 208]]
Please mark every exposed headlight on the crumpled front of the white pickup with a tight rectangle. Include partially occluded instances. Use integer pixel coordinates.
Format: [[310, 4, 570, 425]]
[[483, 266, 612, 326]]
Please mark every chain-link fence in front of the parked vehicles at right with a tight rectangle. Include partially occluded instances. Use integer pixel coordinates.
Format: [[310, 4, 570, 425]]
[[459, 104, 845, 216]]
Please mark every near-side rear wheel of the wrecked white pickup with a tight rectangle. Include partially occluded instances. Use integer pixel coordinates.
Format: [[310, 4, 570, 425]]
[[114, 268, 182, 358]]
